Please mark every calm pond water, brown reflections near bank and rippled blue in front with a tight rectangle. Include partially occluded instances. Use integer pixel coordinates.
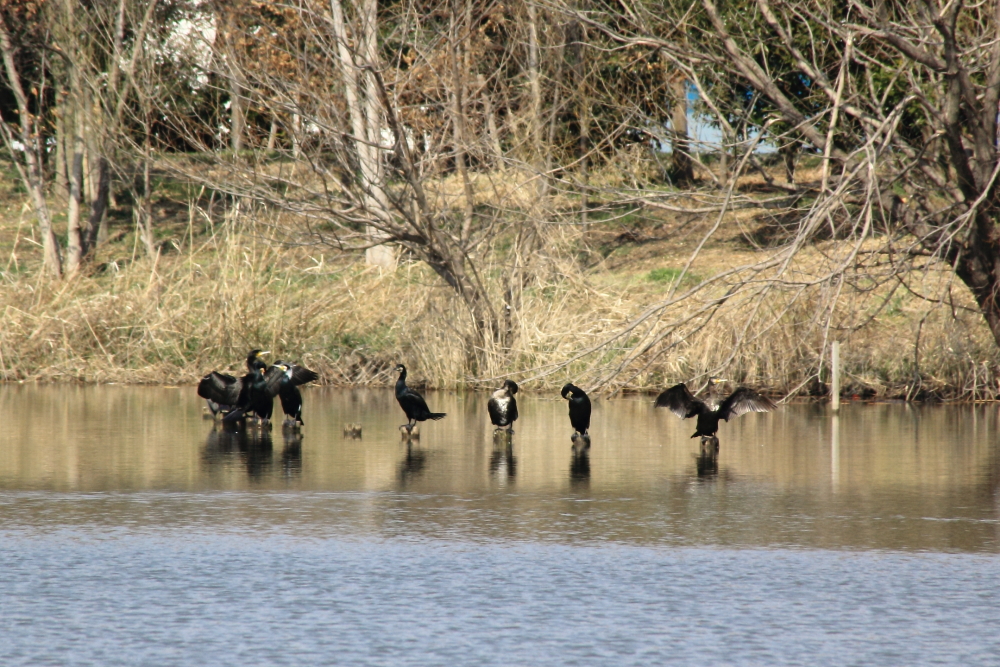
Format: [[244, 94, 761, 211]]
[[0, 385, 1000, 665]]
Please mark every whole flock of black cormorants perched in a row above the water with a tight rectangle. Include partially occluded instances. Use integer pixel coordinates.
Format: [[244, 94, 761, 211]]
[[198, 350, 777, 452]]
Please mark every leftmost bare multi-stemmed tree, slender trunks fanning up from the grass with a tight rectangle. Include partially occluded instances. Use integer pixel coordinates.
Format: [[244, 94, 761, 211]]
[[0, 0, 164, 277]]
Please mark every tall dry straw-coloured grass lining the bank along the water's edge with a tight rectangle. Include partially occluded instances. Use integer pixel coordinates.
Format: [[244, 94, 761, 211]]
[[0, 159, 998, 397]]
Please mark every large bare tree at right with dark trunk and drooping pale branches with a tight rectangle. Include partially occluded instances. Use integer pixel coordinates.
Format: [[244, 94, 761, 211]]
[[508, 0, 1000, 394]]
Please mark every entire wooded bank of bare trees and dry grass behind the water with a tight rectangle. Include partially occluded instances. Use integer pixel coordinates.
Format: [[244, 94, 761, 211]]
[[0, 0, 1000, 399]]
